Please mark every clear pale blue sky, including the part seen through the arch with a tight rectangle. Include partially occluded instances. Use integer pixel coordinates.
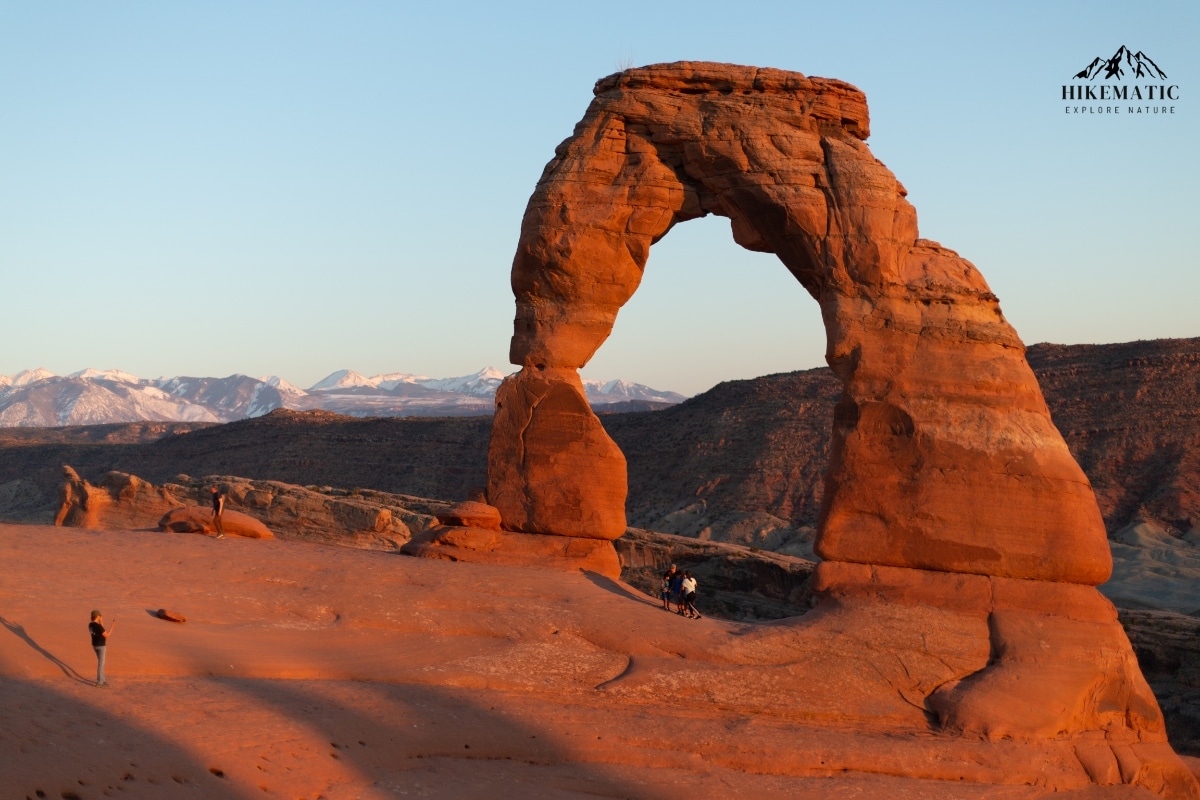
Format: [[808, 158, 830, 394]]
[[0, 0, 1200, 393]]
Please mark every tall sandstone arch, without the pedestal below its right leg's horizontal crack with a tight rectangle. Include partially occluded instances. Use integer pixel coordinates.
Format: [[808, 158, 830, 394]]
[[488, 62, 1110, 584]]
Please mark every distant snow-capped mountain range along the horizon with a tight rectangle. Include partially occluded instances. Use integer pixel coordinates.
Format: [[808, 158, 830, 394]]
[[0, 367, 685, 427]]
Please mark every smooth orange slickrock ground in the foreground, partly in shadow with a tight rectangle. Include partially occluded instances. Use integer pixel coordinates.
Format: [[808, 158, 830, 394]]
[[0, 525, 1180, 800]]
